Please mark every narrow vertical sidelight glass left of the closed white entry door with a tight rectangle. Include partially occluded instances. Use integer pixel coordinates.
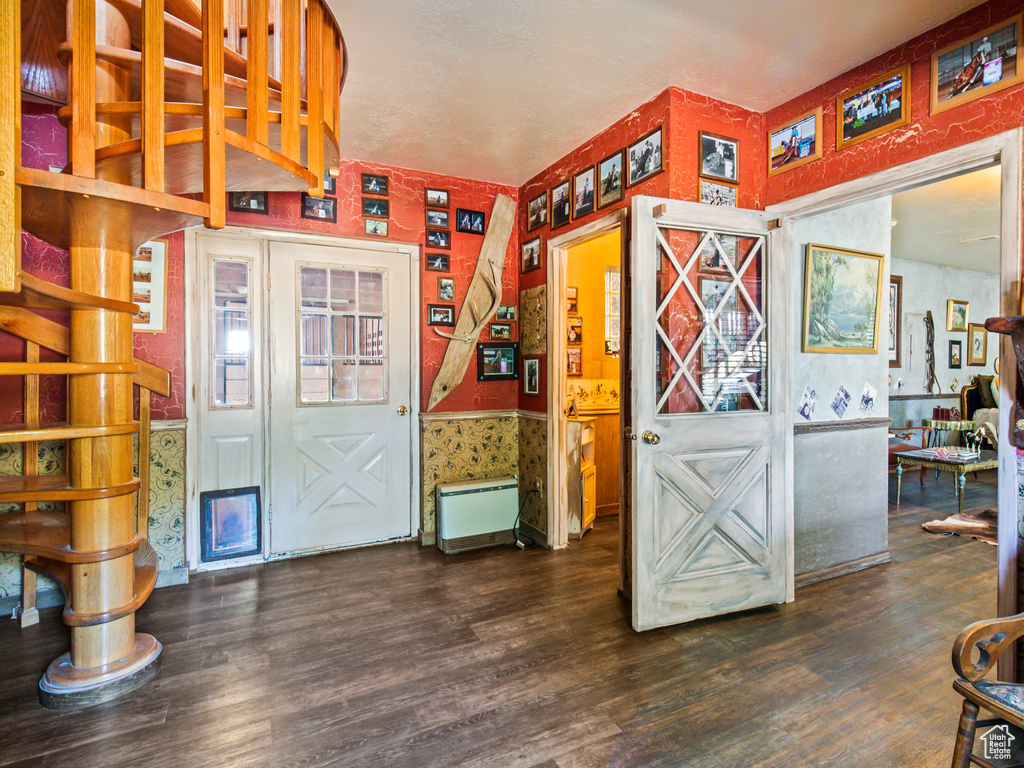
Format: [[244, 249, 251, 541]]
[[210, 259, 253, 408]]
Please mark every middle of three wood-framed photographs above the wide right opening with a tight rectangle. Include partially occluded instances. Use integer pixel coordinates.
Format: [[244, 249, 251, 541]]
[[836, 63, 910, 150]]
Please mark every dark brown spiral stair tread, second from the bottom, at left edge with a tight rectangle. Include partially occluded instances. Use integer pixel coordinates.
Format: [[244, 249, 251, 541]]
[[0, 514, 142, 563]]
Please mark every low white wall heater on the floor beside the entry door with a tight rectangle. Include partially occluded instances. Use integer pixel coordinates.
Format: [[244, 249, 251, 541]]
[[436, 476, 519, 555]]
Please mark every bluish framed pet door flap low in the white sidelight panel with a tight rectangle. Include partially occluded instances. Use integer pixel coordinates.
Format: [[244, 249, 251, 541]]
[[199, 485, 263, 562]]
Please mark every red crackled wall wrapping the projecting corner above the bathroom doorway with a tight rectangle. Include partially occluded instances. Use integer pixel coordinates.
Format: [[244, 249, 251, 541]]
[[519, 87, 767, 412]]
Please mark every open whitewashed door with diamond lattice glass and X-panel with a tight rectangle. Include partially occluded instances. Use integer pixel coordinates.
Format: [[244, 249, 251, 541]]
[[630, 197, 793, 630]]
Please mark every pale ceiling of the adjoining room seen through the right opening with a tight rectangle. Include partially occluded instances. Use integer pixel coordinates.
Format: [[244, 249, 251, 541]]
[[892, 166, 999, 274]]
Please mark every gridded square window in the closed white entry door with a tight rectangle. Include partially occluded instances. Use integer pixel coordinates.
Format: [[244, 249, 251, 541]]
[[297, 266, 388, 403]]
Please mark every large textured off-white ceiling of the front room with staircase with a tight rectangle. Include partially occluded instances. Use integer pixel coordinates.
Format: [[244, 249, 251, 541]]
[[329, 0, 980, 186]]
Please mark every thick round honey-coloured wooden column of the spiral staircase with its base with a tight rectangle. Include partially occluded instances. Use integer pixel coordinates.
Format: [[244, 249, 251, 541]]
[[40, 0, 161, 709]]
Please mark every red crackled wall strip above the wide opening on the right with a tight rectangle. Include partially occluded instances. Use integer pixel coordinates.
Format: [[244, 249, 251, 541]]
[[765, 0, 1024, 205]]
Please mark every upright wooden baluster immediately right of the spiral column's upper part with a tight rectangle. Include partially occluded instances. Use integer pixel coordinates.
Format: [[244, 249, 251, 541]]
[[142, 0, 164, 191]]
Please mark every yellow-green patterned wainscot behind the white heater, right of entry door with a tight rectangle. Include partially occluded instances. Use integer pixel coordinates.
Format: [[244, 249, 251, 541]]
[[420, 416, 519, 534]]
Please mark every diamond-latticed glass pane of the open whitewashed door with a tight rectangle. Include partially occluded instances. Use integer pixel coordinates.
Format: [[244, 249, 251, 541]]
[[654, 228, 767, 414]]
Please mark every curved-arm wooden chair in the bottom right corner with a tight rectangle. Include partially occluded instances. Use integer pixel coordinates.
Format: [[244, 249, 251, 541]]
[[952, 613, 1024, 768]]
